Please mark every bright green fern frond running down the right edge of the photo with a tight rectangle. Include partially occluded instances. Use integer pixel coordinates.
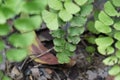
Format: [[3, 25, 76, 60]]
[[86, 0, 120, 80]]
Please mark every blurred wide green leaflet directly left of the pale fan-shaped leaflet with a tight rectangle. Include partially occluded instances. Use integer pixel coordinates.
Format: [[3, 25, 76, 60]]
[[14, 16, 42, 32]]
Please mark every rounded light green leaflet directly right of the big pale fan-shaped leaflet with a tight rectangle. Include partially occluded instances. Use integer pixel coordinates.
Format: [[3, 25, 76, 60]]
[[59, 9, 73, 22]]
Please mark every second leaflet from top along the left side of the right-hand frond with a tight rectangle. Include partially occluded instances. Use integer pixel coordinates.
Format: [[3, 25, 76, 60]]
[[98, 11, 114, 25]]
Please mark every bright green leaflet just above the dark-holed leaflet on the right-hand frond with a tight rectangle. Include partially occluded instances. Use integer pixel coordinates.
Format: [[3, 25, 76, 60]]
[[95, 37, 113, 47]]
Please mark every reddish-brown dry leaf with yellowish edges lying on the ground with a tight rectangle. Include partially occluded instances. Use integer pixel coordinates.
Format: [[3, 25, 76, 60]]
[[29, 37, 59, 65]]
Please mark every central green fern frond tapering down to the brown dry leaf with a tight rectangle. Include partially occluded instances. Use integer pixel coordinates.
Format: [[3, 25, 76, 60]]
[[50, 0, 93, 64]]
